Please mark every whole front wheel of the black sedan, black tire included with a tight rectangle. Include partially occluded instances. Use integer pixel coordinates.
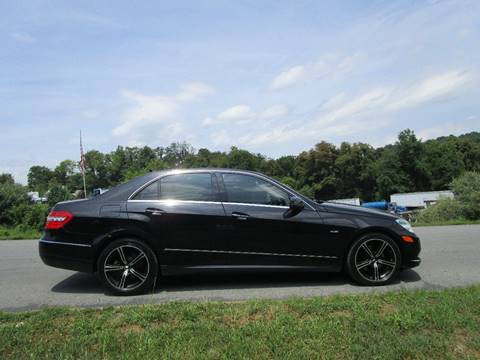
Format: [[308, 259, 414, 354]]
[[345, 233, 402, 286]]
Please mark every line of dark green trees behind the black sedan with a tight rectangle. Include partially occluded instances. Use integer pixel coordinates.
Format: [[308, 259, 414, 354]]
[[28, 129, 480, 201]]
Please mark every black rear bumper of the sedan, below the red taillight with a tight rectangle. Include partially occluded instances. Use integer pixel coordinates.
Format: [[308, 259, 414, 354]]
[[38, 239, 94, 272]]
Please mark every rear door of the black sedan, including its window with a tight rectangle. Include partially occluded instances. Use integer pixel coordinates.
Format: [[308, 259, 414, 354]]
[[128, 172, 225, 266]]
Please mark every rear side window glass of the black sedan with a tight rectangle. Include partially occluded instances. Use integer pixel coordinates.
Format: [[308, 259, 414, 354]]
[[134, 173, 214, 201]]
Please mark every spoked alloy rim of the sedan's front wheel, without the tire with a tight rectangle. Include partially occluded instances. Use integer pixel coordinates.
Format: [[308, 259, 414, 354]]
[[355, 239, 397, 282]]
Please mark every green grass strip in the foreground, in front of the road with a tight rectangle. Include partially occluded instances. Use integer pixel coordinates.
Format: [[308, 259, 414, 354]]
[[0, 286, 480, 359]]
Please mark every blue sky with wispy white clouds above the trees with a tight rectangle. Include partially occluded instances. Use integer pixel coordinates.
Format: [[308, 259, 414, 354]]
[[0, 0, 480, 183]]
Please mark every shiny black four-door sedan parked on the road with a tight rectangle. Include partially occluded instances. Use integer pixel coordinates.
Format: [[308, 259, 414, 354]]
[[39, 169, 420, 295]]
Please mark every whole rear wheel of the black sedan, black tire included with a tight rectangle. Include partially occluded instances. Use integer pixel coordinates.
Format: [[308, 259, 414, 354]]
[[97, 239, 158, 295]]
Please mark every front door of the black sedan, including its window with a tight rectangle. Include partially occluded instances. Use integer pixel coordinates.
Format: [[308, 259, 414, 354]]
[[217, 172, 335, 267]]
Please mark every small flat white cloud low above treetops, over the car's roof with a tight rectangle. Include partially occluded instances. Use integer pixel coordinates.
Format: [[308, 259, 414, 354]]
[[203, 105, 288, 126]]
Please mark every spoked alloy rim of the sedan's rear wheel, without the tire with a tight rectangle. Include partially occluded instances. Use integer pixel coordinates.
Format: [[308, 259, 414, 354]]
[[103, 245, 150, 291]]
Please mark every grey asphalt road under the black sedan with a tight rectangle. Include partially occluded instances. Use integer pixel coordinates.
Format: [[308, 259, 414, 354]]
[[0, 225, 480, 311]]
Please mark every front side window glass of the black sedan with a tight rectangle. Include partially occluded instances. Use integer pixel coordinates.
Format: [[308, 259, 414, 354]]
[[222, 174, 289, 206]]
